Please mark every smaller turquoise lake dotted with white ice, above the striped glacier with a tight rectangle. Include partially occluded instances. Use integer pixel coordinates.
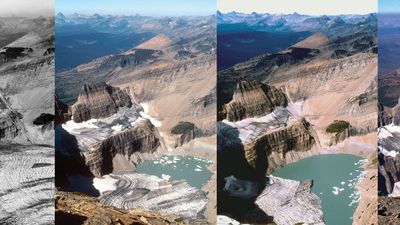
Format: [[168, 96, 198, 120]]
[[135, 155, 212, 189]]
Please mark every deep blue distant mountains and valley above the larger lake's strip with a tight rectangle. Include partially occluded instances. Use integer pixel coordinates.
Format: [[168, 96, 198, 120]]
[[217, 11, 377, 70]]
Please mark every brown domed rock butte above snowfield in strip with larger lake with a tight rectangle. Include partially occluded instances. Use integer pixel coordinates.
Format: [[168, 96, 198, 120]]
[[223, 80, 287, 121]]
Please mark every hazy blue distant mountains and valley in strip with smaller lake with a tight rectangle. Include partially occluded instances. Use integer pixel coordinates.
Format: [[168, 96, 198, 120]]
[[55, 13, 215, 73]]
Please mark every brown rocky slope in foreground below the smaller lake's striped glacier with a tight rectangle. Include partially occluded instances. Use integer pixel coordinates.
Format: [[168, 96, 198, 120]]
[[55, 191, 190, 225]]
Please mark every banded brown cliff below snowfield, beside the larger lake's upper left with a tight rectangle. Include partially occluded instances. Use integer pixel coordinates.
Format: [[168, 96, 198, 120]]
[[244, 119, 315, 173]]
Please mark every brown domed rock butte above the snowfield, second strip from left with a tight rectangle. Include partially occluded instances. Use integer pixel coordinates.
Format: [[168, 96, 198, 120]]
[[71, 83, 132, 123]]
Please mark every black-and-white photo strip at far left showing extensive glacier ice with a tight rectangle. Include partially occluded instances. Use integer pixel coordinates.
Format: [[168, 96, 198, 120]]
[[0, 0, 55, 224]]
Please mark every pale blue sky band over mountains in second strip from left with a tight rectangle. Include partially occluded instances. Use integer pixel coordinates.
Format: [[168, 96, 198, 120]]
[[56, 0, 217, 16]]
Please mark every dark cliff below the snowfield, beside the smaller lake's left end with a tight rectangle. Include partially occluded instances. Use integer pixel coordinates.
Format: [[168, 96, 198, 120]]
[[84, 119, 161, 176]]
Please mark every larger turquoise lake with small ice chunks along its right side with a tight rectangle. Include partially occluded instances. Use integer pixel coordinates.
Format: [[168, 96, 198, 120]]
[[273, 154, 365, 225]]
